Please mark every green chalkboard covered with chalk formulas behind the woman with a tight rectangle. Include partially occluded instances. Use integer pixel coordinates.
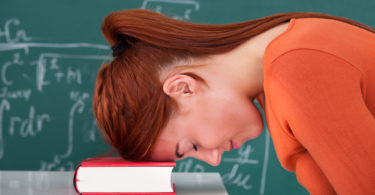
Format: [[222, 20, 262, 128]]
[[0, 0, 375, 194]]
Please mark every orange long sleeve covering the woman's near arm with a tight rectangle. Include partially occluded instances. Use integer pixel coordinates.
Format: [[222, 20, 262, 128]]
[[266, 49, 375, 195]]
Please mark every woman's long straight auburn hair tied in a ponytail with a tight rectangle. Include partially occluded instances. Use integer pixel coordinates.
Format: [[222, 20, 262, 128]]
[[93, 9, 375, 161]]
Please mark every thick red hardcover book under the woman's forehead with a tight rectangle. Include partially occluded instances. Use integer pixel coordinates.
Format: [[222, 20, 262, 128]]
[[73, 157, 176, 195]]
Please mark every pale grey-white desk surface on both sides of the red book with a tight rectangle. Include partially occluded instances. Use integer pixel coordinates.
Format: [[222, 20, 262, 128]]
[[0, 171, 228, 195]]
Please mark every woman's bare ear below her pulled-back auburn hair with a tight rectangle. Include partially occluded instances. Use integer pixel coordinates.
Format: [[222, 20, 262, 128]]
[[163, 74, 199, 98]]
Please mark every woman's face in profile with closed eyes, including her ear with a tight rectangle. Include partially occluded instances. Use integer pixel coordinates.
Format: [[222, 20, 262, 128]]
[[151, 72, 263, 166]]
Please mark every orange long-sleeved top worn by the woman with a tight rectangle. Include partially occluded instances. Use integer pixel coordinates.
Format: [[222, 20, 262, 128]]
[[257, 18, 375, 195]]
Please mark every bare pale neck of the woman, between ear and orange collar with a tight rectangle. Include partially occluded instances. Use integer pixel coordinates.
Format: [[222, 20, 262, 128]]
[[182, 22, 289, 100]]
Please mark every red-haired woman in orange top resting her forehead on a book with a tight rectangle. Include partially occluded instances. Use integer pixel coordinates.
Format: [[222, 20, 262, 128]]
[[93, 10, 375, 194]]
